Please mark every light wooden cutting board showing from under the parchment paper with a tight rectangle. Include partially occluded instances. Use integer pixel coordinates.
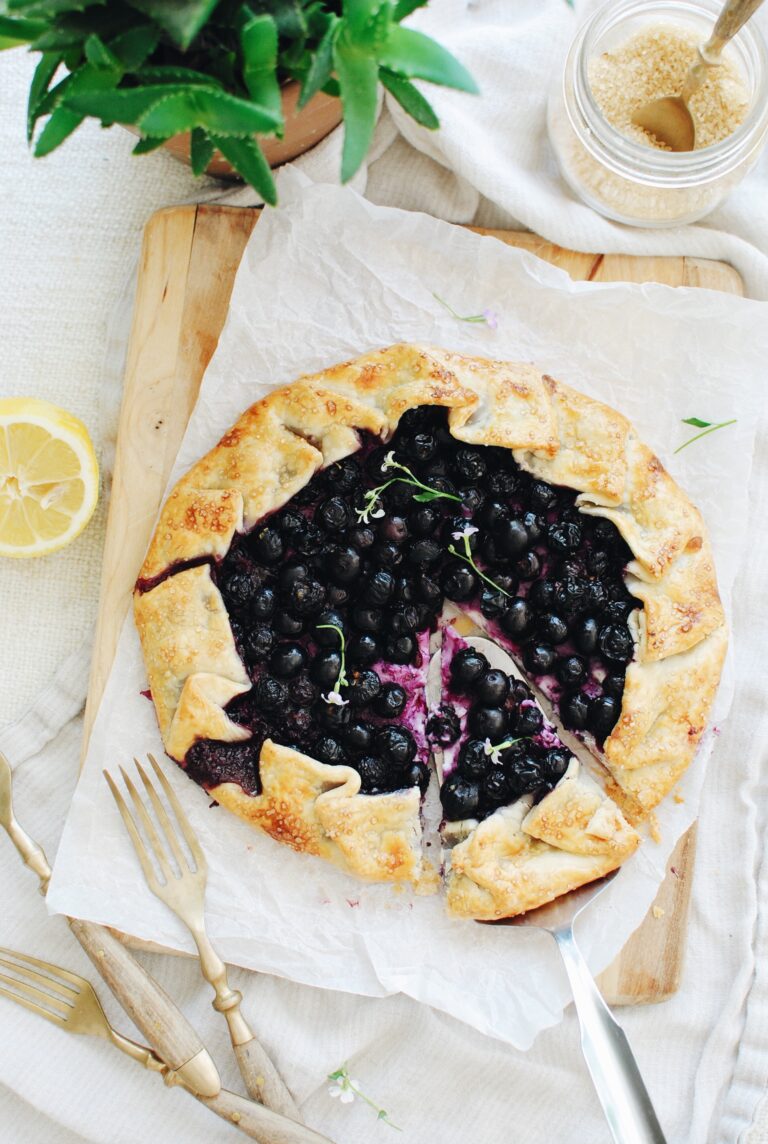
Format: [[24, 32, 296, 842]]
[[84, 206, 744, 1004]]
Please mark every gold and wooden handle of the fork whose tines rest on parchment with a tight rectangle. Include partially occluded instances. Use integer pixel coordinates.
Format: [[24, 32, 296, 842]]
[[191, 924, 301, 1120]]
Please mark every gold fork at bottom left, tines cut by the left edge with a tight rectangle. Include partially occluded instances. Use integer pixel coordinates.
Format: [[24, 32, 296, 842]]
[[0, 946, 332, 1144]]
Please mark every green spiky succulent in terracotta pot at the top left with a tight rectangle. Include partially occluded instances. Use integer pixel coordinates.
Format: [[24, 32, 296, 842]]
[[0, 0, 477, 204]]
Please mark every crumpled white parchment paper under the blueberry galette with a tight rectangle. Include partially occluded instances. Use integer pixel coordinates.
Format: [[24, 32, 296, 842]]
[[48, 168, 768, 1049]]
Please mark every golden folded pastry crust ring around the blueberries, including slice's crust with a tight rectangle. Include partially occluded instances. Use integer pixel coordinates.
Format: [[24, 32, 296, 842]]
[[134, 344, 727, 917]]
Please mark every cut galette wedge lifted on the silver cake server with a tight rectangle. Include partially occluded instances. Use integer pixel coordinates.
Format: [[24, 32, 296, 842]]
[[427, 626, 640, 921]]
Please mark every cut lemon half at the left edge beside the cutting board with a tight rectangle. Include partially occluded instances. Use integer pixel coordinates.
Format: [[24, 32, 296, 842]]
[[0, 397, 98, 557]]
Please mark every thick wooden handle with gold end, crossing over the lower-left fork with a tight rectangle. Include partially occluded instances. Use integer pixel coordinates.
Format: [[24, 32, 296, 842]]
[[68, 917, 221, 1097]]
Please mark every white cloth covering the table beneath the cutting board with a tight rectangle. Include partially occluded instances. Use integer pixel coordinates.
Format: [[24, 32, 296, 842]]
[[0, 0, 768, 1144]]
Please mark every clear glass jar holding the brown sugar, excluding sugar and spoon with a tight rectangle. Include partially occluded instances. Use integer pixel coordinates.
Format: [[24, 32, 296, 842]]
[[547, 0, 768, 227]]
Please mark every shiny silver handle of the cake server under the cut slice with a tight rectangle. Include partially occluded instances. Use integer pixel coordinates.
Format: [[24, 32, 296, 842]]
[[552, 925, 665, 1144]]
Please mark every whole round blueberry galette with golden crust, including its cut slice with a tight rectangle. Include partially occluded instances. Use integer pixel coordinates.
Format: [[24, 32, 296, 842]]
[[135, 345, 727, 917]]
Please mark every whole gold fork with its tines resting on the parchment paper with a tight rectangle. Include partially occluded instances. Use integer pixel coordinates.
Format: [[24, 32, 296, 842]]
[[104, 755, 300, 1121]]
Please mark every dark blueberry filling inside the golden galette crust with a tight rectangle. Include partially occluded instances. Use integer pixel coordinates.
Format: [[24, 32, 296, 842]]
[[180, 406, 641, 819]]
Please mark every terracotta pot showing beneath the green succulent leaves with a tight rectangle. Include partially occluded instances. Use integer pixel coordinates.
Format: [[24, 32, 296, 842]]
[[146, 81, 341, 178]]
